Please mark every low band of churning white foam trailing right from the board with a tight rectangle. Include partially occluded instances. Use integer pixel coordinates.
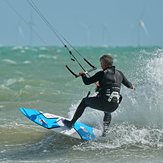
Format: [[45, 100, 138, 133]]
[[73, 123, 163, 151]]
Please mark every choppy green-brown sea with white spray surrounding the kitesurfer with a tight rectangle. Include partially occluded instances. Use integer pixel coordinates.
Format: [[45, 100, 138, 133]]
[[0, 47, 163, 163]]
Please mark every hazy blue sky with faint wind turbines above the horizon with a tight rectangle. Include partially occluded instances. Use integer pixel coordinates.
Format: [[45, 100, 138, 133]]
[[0, 0, 163, 46]]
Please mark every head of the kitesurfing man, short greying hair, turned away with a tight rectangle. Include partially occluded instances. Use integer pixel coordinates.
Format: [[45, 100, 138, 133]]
[[100, 54, 113, 70]]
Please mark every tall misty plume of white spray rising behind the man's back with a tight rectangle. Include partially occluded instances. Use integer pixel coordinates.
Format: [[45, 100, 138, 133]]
[[113, 50, 163, 126]]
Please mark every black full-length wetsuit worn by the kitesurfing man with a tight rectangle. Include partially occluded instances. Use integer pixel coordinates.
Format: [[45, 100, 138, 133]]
[[63, 66, 133, 131]]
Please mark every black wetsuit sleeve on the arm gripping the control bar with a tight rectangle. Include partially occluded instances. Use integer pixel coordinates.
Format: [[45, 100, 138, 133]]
[[82, 71, 104, 85]]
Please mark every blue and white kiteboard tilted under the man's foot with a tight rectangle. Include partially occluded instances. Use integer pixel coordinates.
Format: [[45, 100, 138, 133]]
[[20, 108, 102, 141]]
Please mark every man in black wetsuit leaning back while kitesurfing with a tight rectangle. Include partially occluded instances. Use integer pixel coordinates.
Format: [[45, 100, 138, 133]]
[[64, 55, 134, 135]]
